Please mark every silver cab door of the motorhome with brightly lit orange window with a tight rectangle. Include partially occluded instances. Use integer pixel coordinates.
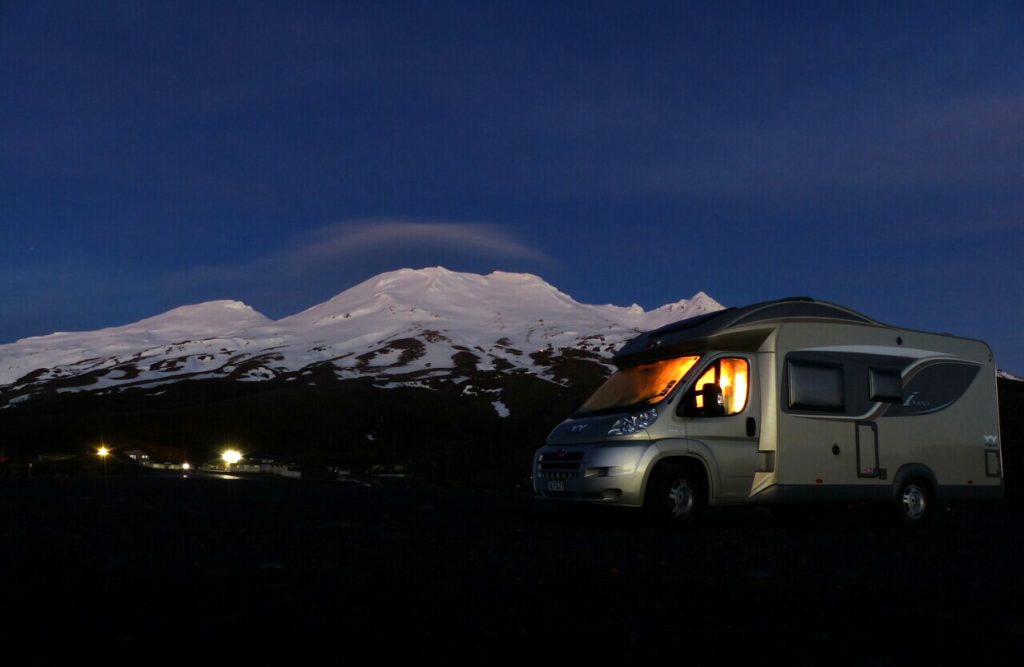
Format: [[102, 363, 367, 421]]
[[676, 355, 761, 500]]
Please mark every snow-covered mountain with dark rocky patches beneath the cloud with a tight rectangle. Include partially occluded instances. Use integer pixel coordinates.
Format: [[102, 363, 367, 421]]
[[0, 267, 722, 407]]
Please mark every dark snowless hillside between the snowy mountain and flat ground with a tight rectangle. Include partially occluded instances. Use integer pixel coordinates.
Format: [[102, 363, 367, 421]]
[[0, 362, 603, 488]]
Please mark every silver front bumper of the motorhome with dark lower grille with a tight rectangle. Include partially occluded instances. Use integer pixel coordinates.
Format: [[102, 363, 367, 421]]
[[534, 443, 650, 507]]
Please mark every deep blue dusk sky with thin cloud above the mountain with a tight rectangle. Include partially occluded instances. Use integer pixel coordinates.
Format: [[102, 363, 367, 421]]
[[0, 0, 1024, 374]]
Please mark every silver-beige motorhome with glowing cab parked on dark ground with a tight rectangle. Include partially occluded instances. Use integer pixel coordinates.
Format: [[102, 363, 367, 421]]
[[532, 297, 1002, 524]]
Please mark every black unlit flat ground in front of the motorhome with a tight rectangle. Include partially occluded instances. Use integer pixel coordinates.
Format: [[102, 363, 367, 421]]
[[0, 477, 1024, 666]]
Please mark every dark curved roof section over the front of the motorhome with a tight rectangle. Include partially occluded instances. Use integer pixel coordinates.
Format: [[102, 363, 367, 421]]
[[612, 296, 887, 366]]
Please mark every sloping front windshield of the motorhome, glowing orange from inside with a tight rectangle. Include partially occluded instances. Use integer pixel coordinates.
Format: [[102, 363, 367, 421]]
[[577, 356, 700, 415]]
